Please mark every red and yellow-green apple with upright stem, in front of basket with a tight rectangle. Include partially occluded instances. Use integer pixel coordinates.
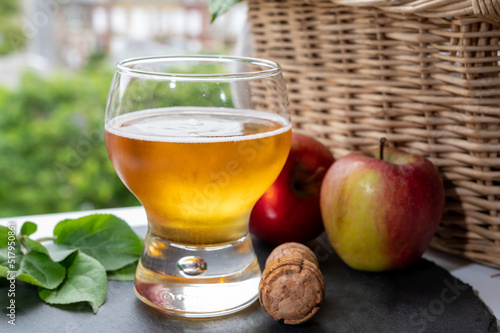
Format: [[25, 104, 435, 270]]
[[321, 140, 445, 271]]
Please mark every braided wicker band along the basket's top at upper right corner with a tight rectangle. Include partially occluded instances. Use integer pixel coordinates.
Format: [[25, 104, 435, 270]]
[[331, 0, 500, 26]]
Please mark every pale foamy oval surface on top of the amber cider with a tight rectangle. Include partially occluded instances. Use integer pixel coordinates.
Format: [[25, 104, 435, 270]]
[[106, 107, 291, 143]]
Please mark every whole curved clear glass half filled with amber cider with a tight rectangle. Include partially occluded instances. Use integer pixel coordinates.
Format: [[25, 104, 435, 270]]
[[105, 56, 291, 317]]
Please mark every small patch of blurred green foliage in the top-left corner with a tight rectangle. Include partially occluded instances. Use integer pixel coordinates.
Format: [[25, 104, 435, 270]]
[[0, 0, 27, 55]]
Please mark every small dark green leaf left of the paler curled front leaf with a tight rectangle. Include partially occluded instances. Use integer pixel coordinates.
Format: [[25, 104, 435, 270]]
[[16, 251, 66, 289]]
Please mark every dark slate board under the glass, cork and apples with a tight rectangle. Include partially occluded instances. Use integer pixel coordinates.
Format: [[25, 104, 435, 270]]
[[0, 228, 497, 333]]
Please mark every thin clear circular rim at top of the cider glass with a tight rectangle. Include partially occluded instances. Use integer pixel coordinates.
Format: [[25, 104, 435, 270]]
[[116, 55, 281, 81]]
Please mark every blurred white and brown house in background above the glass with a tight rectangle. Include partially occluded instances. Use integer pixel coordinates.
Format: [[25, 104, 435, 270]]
[[50, 0, 245, 67]]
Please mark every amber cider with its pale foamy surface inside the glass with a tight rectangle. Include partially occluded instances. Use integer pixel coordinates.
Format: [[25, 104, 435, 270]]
[[105, 108, 291, 246]]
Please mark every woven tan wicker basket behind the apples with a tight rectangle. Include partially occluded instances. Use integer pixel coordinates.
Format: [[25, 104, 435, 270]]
[[247, 0, 500, 267]]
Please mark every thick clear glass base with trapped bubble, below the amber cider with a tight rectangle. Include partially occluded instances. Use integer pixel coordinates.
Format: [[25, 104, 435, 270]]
[[135, 234, 261, 318]]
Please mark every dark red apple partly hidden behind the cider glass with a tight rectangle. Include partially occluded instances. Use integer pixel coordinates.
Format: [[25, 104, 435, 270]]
[[250, 132, 334, 244]]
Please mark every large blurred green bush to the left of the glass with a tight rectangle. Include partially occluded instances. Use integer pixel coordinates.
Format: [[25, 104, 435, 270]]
[[0, 61, 139, 217]]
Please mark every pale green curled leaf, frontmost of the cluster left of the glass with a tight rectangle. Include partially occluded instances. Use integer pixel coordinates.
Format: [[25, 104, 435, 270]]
[[38, 251, 108, 313]]
